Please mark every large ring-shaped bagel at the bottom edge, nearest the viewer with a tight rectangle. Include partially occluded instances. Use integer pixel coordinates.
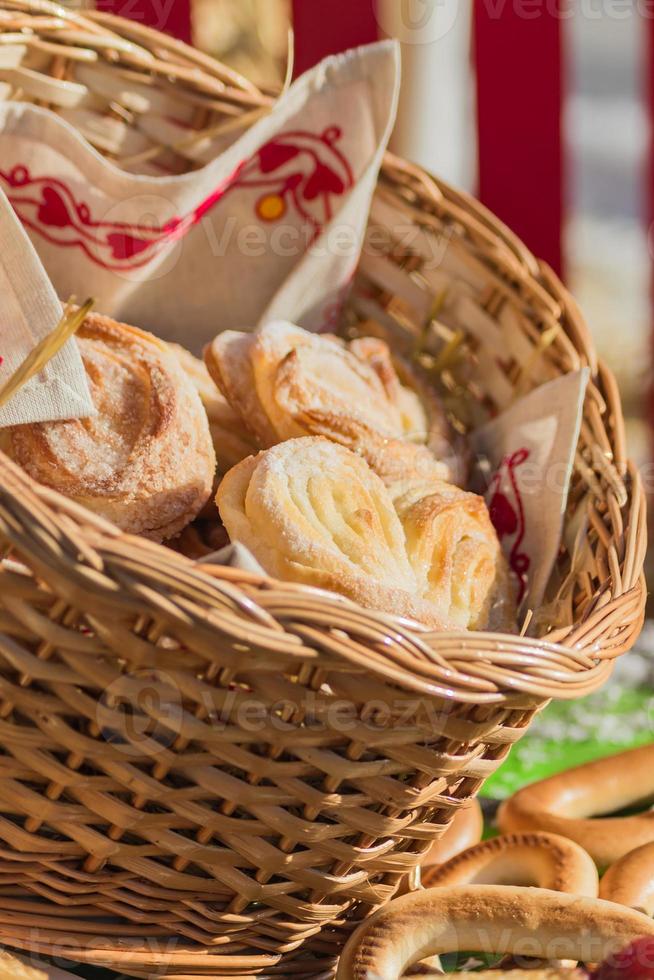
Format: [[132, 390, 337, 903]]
[[336, 885, 654, 980]]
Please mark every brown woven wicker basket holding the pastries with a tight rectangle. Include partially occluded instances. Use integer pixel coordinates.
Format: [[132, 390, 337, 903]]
[[0, 0, 645, 977]]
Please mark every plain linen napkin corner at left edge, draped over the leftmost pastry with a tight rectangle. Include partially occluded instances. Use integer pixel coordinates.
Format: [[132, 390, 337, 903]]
[[0, 191, 95, 428]]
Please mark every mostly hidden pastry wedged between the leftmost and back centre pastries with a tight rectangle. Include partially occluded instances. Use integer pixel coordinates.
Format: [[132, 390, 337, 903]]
[[170, 344, 258, 474]]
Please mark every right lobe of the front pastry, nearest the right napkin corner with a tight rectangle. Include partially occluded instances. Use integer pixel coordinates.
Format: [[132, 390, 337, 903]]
[[389, 479, 515, 631]]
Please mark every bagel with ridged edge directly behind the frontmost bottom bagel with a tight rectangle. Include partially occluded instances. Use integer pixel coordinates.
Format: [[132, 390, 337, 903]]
[[422, 833, 599, 898]]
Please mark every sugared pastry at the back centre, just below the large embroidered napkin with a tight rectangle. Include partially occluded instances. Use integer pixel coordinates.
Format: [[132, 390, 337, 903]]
[[205, 323, 462, 482]]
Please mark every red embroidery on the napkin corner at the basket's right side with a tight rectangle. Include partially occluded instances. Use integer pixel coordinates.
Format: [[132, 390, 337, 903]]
[[488, 449, 531, 603]]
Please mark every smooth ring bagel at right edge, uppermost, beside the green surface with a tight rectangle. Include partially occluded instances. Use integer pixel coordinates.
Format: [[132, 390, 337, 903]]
[[498, 745, 654, 868]]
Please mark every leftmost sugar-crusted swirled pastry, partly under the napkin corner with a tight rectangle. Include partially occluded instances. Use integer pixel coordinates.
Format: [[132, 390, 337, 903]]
[[0, 314, 216, 541]]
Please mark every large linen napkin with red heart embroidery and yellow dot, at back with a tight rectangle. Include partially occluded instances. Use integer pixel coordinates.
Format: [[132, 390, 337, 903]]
[[0, 41, 399, 352]]
